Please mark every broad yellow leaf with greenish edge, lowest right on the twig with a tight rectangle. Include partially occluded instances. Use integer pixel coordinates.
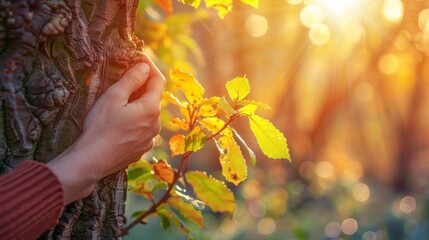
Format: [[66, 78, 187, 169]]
[[186, 171, 235, 215]]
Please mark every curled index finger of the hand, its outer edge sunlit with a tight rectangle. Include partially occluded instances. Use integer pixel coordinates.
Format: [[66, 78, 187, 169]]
[[135, 57, 165, 105]]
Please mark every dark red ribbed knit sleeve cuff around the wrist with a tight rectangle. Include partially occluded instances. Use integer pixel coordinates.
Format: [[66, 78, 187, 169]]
[[0, 161, 64, 239]]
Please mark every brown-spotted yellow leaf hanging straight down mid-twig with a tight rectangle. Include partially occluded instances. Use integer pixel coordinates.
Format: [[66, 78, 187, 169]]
[[219, 135, 247, 185]]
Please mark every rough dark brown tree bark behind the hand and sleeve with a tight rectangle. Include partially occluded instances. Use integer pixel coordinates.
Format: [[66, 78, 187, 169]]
[[0, 0, 144, 239]]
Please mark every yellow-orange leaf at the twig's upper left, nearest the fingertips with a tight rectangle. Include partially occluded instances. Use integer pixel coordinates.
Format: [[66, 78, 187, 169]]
[[170, 69, 204, 104]]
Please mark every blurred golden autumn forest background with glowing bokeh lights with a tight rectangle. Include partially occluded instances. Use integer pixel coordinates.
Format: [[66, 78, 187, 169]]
[[125, 0, 429, 240]]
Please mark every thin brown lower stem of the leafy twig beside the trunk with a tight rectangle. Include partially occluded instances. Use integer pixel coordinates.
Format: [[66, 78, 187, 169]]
[[122, 151, 192, 235]]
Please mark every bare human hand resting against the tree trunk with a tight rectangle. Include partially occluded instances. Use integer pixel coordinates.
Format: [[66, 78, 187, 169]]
[[48, 55, 165, 202]]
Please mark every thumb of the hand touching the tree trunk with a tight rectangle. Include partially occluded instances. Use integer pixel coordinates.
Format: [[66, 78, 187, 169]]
[[112, 63, 150, 102]]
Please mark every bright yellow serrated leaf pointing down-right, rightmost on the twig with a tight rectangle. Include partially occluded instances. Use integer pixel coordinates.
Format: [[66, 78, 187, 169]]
[[249, 115, 291, 161]]
